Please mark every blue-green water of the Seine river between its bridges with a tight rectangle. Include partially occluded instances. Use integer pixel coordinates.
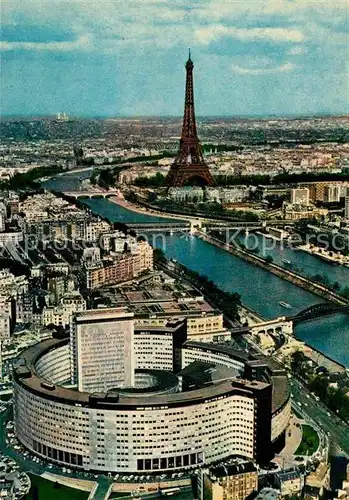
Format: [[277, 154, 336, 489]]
[[42, 176, 349, 367]]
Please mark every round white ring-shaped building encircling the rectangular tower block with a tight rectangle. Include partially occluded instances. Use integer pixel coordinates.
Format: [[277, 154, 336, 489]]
[[14, 336, 290, 473]]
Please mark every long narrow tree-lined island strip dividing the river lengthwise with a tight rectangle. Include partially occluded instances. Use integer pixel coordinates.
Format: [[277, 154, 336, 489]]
[[195, 231, 349, 306]]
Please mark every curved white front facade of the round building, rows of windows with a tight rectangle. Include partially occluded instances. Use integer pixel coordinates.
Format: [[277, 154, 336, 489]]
[[14, 376, 255, 472]]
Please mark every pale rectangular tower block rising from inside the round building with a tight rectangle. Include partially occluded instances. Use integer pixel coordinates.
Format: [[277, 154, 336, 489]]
[[70, 308, 134, 392]]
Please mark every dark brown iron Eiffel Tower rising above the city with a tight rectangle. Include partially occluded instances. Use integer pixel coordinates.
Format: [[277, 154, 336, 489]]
[[166, 50, 214, 187]]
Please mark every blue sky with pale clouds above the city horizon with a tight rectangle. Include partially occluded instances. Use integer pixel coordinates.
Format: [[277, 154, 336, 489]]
[[0, 0, 349, 116]]
